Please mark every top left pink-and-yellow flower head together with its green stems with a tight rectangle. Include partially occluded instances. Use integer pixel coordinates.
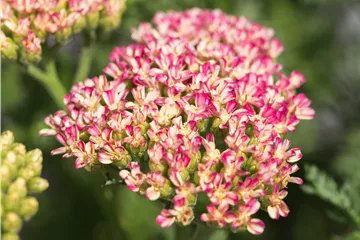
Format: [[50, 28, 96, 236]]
[[0, 0, 125, 106]]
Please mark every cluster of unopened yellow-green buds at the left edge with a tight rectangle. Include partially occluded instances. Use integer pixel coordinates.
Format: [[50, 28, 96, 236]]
[[0, 131, 49, 240]]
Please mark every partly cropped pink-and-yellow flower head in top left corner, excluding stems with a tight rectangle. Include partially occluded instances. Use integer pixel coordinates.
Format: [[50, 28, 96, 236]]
[[0, 0, 125, 62]]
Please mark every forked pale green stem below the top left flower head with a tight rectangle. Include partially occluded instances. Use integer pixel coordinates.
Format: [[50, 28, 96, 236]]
[[27, 60, 66, 108]]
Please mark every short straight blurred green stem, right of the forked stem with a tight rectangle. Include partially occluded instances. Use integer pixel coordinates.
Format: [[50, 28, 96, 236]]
[[74, 44, 95, 83]]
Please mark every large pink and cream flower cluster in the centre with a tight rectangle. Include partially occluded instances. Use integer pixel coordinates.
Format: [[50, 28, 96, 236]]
[[40, 9, 314, 234]]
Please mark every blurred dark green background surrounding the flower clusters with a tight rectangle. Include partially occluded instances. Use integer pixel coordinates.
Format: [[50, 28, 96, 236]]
[[0, 0, 360, 240]]
